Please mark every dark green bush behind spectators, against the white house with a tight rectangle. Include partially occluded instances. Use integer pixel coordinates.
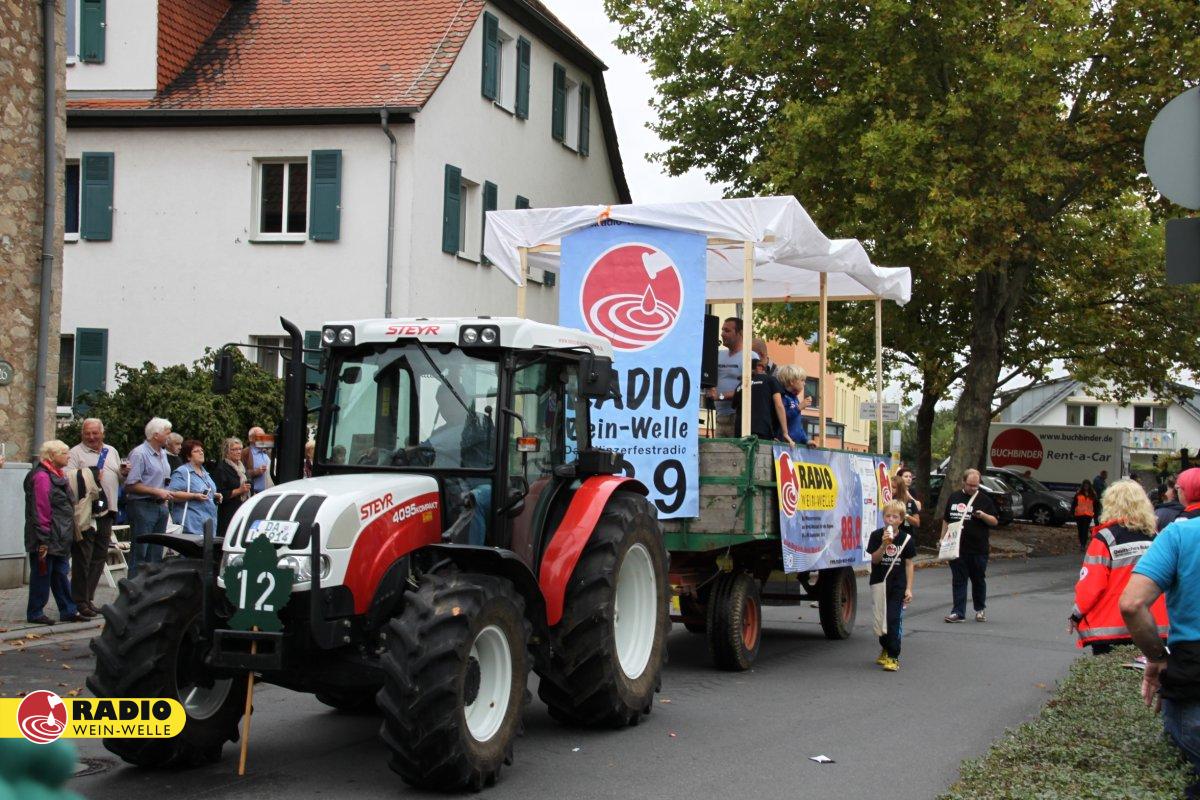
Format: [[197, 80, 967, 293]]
[[59, 350, 283, 461]]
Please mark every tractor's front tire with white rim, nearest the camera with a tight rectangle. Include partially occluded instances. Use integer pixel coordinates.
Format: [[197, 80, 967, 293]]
[[378, 572, 529, 792]]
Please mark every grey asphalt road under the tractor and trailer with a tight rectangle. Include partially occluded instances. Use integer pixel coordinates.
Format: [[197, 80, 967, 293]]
[[0, 557, 1079, 800]]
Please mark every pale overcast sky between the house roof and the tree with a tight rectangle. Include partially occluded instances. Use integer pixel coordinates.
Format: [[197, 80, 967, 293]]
[[542, 0, 721, 203]]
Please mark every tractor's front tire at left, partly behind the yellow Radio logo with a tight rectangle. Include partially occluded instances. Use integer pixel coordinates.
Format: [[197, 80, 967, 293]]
[[88, 558, 247, 768]]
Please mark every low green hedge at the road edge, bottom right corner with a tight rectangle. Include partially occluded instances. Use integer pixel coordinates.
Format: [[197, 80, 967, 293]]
[[942, 648, 1189, 800]]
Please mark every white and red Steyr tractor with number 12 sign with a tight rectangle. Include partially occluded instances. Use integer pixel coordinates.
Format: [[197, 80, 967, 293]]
[[88, 317, 670, 789]]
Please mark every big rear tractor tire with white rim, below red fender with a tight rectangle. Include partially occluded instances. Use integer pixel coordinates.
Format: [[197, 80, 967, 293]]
[[538, 491, 671, 727]]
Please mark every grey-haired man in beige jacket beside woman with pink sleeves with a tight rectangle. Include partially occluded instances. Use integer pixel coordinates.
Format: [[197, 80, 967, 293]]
[[67, 417, 121, 618]]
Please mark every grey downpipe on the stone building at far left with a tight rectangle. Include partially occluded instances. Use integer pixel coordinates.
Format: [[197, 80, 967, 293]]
[[30, 0, 59, 450]]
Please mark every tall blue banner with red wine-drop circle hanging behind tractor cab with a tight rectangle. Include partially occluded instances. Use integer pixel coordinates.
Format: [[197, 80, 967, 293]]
[[558, 224, 707, 519]]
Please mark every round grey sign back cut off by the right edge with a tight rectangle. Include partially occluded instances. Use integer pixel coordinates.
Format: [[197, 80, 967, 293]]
[[1146, 86, 1200, 209]]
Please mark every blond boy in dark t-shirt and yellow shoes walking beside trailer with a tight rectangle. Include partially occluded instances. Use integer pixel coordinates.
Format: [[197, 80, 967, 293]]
[[866, 500, 917, 672]]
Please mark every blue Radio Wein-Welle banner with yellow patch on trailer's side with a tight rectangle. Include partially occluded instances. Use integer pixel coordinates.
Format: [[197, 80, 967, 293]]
[[774, 445, 887, 572]]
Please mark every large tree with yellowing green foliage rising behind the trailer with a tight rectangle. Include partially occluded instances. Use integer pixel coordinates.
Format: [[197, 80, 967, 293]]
[[606, 0, 1200, 525]]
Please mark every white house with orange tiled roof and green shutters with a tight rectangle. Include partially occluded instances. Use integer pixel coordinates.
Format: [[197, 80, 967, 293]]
[[60, 0, 630, 404]]
